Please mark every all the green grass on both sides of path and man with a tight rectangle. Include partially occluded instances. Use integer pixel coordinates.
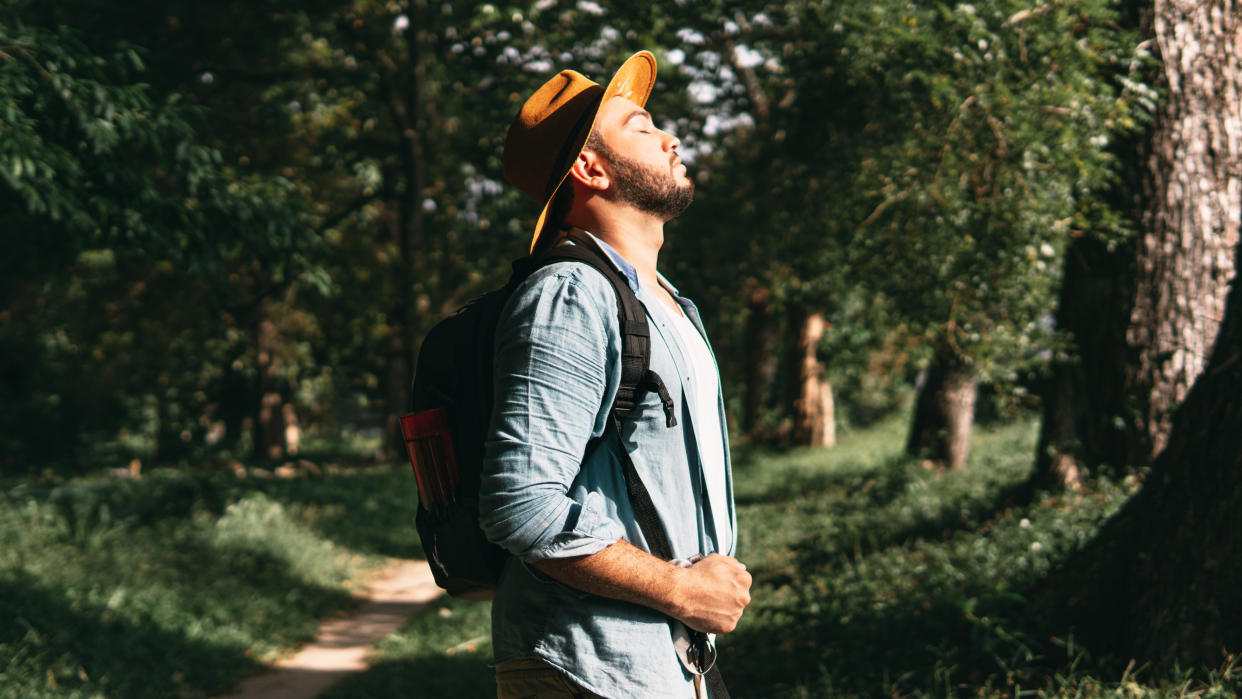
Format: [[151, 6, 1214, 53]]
[[0, 421, 1242, 699]]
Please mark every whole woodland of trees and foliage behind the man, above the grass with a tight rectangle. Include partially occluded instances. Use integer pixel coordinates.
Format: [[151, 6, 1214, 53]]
[[0, 0, 1242, 689]]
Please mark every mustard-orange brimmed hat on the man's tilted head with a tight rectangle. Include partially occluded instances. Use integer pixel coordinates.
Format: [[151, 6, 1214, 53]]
[[503, 51, 656, 252]]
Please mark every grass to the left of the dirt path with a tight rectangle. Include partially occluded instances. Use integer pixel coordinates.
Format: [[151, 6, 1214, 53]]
[[0, 467, 421, 698]]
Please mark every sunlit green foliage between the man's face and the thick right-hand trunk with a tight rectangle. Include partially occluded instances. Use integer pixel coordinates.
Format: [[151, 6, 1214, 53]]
[[671, 0, 1153, 427]]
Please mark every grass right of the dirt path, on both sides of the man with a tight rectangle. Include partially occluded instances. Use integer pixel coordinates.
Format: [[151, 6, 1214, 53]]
[[329, 420, 1242, 699]]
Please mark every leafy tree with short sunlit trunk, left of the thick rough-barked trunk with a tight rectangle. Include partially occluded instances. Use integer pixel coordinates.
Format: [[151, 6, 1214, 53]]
[[838, 2, 1133, 468]]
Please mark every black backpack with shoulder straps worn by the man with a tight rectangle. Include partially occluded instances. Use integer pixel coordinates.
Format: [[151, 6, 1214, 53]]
[[401, 231, 677, 600]]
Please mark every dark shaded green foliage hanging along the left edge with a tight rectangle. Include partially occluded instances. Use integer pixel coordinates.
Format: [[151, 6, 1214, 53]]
[[0, 0, 313, 471]]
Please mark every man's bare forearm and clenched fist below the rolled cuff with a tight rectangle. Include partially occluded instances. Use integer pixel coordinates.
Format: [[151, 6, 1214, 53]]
[[534, 540, 750, 633]]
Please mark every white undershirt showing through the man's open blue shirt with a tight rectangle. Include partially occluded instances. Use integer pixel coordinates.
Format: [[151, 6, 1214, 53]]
[[661, 304, 733, 554]]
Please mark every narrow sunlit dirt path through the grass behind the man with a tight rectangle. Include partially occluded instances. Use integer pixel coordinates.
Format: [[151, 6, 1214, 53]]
[[226, 561, 442, 699]]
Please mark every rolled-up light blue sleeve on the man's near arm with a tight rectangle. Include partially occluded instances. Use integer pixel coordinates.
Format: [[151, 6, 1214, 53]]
[[479, 263, 625, 561]]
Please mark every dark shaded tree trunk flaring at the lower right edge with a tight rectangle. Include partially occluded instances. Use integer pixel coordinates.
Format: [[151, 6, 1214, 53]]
[[1043, 233, 1242, 668]]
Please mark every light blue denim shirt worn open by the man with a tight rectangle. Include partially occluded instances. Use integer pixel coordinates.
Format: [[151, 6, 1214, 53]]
[[479, 237, 737, 698]]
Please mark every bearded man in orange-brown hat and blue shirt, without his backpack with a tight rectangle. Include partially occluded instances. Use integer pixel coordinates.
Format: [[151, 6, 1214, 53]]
[[479, 51, 750, 698]]
